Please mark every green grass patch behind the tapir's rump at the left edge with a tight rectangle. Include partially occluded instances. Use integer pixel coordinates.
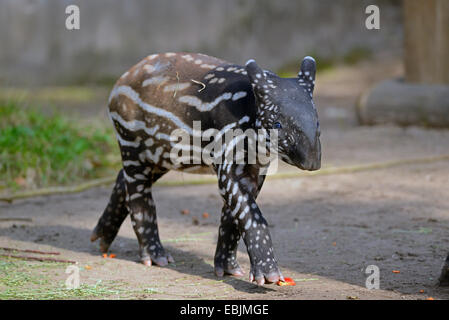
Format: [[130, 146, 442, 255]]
[[0, 100, 119, 190]]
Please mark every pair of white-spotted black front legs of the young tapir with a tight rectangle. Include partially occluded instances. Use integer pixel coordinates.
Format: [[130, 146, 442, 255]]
[[215, 164, 282, 285]]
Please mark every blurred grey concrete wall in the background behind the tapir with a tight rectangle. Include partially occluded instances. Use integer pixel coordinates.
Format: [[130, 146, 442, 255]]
[[0, 0, 402, 85]]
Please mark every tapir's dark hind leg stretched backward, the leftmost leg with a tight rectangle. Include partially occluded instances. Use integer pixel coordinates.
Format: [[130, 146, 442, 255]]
[[90, 169, 129, 253]]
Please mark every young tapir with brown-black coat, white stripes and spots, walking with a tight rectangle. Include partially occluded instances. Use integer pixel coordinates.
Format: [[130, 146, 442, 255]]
[[91, 53, 321, 285]]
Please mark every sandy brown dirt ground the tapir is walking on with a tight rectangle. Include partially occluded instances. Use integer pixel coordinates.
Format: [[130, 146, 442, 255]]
[[0, 56, 449, 299]]
